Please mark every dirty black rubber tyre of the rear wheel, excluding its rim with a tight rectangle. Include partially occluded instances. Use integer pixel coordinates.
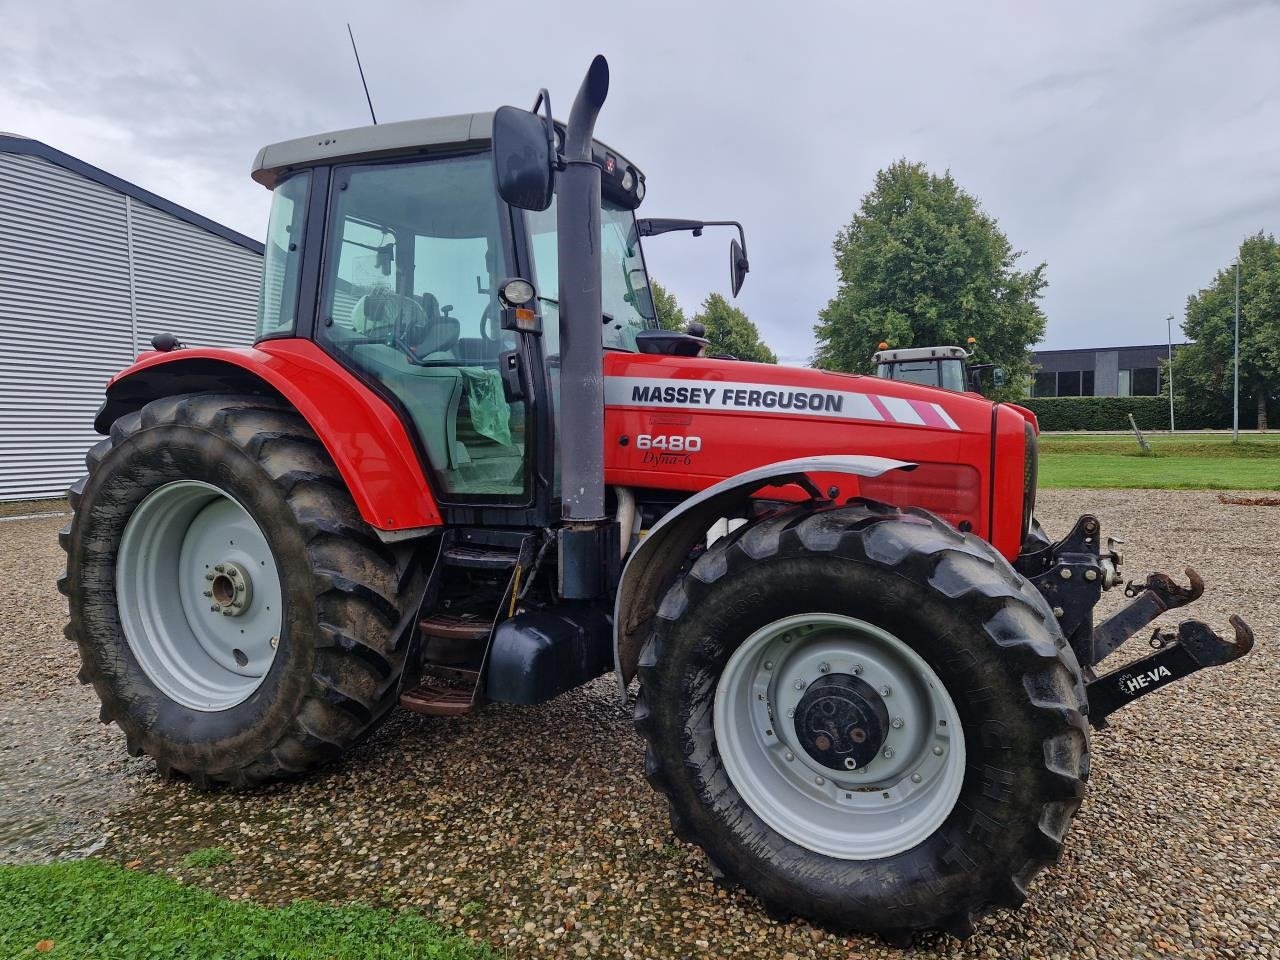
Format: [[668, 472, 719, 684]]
[[59, 394, 412, 787]]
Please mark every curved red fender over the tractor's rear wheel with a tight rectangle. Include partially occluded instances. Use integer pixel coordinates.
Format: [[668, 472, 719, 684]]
[[93, 339, 443, 535]]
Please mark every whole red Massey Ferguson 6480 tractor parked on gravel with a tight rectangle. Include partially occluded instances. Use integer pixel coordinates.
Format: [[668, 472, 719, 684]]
[[60, 58, 1253, 938]]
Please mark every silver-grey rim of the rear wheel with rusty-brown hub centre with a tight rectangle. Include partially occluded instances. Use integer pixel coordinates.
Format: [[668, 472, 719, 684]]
[[115, 480, 284, 712]]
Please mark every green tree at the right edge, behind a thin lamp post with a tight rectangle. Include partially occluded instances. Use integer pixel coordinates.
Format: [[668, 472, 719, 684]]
[[1174, 232, 1280, 430]]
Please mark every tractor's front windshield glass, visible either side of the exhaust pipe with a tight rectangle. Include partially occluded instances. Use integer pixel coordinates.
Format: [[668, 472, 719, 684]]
[[526, 198, 655, 356]]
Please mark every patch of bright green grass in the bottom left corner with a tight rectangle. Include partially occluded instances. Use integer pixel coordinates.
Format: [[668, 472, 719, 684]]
[[0, 860, 494, 960]]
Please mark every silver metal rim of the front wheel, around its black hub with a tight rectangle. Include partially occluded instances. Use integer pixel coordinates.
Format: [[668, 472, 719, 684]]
[[713, 613, 965, 860]]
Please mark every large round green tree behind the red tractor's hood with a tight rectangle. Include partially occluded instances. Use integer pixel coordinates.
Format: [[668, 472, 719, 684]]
[[814, 160, 1047, 398]]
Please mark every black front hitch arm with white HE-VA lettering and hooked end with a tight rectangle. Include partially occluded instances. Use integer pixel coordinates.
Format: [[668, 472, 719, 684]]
[[1084, 616, 1253, 727]]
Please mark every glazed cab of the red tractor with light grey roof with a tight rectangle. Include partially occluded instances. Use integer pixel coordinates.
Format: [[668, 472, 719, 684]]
[[253, 113, 657, 511]]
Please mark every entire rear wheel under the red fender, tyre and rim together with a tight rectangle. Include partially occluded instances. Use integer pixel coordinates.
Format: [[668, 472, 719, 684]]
[[59, 394, 407, 787]]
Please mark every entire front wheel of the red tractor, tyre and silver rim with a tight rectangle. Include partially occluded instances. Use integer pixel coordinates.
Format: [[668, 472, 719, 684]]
[[635, 502, 1089, 938]]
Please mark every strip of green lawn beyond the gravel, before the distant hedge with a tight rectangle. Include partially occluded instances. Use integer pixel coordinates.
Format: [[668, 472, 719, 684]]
[[1039, 434, 1280, 490]]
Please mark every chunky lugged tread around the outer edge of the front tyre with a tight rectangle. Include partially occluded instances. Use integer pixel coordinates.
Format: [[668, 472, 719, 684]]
[[634, 499, 1088, 941]]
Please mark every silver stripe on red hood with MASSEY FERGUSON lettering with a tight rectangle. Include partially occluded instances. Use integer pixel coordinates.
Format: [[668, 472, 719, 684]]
[[604, 376, 960, 430]]
